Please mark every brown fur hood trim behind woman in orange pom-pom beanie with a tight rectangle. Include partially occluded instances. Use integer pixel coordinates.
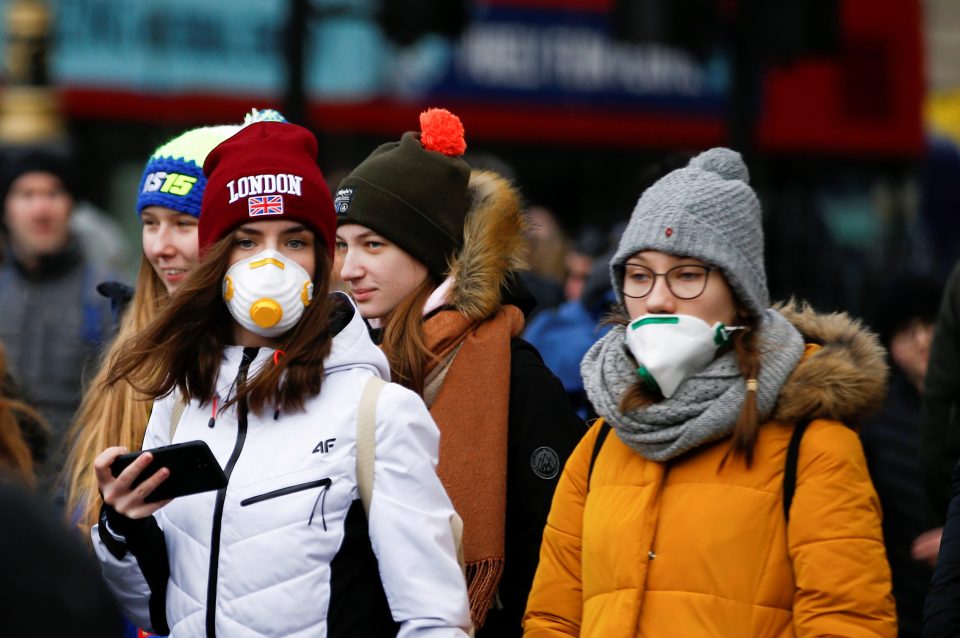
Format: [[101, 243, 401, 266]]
[[449, 171, 526, 320]]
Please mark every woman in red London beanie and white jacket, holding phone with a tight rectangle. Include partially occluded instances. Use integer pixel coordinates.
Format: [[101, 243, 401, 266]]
[[93, 122, 470, 638]]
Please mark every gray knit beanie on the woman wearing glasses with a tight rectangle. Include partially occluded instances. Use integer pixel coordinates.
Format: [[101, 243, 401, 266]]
[[610, 148, 770, 316]]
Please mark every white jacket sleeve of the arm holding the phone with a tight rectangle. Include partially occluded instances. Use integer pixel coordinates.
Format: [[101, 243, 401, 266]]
[[91, 397, 173, 632]]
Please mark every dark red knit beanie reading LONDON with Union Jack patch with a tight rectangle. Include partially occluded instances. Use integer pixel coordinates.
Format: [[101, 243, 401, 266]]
[[198, 122, 337, 257]]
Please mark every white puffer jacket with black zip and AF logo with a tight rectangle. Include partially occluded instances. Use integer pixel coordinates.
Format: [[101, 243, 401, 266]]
[[93, 298, 470, 638]]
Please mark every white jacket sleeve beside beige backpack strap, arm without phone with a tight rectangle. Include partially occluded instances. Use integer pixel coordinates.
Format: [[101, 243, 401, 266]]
[[369, 383, 470, 638]]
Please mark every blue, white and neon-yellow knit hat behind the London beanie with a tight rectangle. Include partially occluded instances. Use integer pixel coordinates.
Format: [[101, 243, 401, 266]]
[[137, 109, 287, 217]]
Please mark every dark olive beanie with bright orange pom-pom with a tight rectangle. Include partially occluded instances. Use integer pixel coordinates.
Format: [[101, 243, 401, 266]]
[[334, 109, 470, 280]]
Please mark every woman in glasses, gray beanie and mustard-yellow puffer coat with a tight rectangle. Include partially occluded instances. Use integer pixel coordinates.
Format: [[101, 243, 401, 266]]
[[524, 149, 896, 638]]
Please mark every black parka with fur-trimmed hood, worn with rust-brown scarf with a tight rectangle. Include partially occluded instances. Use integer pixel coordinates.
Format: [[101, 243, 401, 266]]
[[404, 171, 586, 638]]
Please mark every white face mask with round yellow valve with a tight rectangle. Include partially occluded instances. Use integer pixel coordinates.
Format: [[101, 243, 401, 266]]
[[223, 250, 313, 337]]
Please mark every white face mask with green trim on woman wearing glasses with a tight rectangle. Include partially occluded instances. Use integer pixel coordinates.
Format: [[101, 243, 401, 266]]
[[626, 315, 741, 398]]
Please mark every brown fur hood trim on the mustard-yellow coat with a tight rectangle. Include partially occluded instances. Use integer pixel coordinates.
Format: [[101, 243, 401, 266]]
[[773, 300, 888, 427]]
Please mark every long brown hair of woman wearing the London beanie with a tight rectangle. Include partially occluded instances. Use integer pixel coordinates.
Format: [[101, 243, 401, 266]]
[[106, 232, 333, 413]]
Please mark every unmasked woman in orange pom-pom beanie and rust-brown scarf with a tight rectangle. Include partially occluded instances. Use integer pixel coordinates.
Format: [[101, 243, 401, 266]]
[[334, 109, 584, 638]]
